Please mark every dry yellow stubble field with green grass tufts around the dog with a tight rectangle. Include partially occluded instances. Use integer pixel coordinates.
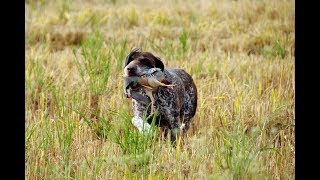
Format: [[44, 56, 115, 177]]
[[25, 0, 295, 179]]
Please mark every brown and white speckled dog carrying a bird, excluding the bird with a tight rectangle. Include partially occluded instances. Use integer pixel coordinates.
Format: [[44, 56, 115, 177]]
[[124, 48, 198, 142]]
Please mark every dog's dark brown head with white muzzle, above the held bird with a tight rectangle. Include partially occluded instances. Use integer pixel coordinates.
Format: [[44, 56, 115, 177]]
[[124, 48, 164, 76]]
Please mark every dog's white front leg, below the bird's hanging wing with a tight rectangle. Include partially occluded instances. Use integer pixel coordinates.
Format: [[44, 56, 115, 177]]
[[131, 99, 151, 133]]
